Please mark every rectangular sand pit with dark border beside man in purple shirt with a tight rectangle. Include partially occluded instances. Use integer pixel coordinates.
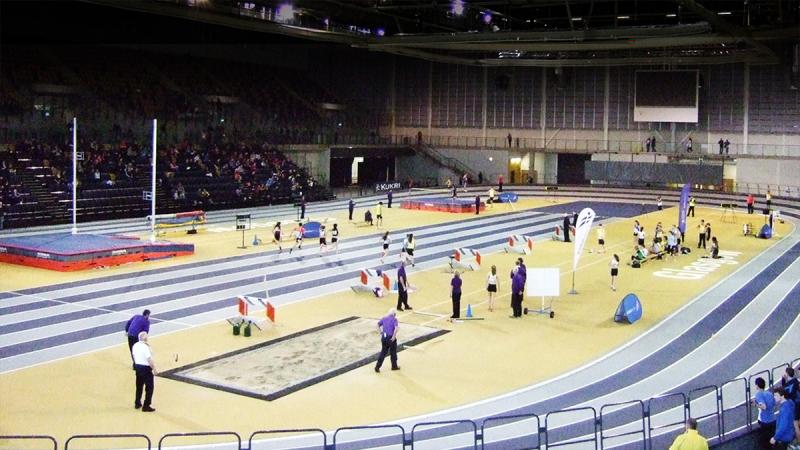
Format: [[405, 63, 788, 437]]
[[161, 317, 448, 400]]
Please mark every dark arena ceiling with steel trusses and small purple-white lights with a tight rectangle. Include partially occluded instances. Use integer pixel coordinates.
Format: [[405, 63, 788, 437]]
[[3, 0, 800, 67]]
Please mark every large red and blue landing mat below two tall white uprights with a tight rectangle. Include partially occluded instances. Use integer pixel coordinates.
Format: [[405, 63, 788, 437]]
[[0, 233, 194, 272]]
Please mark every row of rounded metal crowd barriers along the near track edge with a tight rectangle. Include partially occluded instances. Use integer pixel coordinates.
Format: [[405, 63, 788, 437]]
[[0, 358, 800, 450]]
